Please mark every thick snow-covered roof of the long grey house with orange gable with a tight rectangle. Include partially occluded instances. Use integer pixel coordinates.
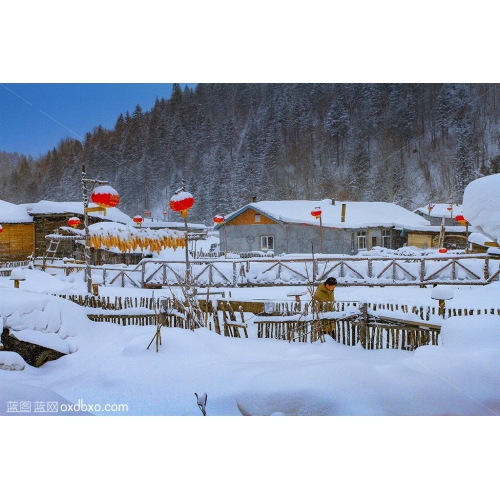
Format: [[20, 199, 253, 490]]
[[225, 199, 431, 229]]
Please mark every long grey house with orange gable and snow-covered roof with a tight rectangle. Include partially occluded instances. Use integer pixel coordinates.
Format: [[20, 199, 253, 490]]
[[216, 199, 430, 255]]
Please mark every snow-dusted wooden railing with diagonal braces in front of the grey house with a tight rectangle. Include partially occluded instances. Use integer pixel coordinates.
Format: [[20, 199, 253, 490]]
[[36, 254, 500, 288]]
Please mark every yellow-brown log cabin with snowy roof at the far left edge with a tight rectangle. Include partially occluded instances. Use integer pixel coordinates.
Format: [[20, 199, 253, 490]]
[[0, 200, 35, 262]]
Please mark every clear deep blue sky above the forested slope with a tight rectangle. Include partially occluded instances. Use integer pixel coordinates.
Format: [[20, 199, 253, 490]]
[[0, 83, 195, 157]]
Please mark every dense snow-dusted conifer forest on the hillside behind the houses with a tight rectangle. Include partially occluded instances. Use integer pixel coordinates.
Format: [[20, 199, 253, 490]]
[[0, 83, 500, 224]]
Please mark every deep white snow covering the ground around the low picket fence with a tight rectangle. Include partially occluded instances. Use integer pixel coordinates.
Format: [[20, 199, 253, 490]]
[[0, 270, 500, 416]]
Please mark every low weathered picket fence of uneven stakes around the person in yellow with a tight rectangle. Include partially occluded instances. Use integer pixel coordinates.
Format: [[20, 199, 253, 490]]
[[51, 295, 500, 351]]
